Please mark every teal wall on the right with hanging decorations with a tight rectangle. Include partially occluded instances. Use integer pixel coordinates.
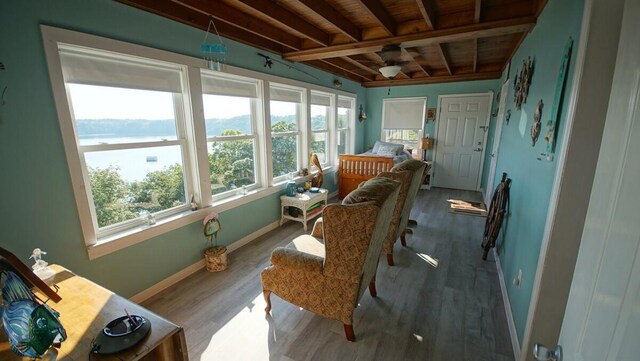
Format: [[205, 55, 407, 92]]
[[489, 0, 584, 342]]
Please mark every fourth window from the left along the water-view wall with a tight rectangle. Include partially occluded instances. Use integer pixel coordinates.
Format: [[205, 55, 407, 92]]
[[311, 91, 333, 165]]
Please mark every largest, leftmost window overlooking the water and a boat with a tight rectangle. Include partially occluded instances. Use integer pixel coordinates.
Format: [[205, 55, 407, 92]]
[[60, 45, 192, 237]]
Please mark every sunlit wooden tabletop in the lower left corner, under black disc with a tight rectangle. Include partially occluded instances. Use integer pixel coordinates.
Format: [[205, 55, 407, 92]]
[[0, 265, 188, 361]]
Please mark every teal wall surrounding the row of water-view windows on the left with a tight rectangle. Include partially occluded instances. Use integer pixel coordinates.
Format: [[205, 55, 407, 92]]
[[0, 0, 365, 297]]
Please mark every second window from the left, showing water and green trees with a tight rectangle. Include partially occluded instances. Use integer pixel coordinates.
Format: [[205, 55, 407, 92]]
[[202, 73, 260, 199]]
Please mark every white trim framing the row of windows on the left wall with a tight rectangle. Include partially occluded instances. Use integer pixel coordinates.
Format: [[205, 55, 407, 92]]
[[40, 25, 357, 259]]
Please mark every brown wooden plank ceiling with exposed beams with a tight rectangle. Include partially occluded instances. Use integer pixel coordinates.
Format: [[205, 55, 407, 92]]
[[118, 0, 547, 87]]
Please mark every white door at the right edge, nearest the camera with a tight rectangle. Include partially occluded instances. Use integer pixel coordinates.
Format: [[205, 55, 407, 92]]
[[559, 0, 640, 361]]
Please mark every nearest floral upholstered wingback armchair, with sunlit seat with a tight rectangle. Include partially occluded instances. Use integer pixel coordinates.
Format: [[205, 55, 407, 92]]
[[262, 178, 400, 341]]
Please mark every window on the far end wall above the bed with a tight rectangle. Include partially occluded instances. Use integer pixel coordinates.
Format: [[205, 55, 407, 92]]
[[381, 97, 427, 149]]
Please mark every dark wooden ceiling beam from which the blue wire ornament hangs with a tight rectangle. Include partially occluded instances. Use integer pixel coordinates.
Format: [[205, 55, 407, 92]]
[[173, 0, 302, 50]]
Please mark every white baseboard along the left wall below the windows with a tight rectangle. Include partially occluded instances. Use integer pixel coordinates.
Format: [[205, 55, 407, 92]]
[[130, 220, 280, 303]]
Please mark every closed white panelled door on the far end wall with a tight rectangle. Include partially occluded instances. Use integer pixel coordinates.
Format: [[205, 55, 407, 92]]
[[433, 93, 492, 191]]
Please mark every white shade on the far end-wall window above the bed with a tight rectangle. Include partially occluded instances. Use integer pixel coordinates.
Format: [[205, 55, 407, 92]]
[[382, 97, 427, 129]]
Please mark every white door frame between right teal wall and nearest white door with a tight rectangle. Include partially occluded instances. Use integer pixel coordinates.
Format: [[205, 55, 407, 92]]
[[518, 0, 624, 361]]
